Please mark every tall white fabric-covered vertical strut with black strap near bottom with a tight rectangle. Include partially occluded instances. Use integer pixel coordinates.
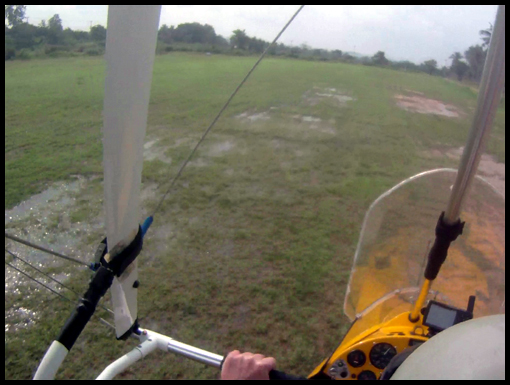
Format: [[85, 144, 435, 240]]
[[103, 5, 161, 337]]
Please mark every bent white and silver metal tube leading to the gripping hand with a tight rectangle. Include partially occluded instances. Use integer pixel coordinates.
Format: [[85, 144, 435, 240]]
[[97, 330, 223, 380]]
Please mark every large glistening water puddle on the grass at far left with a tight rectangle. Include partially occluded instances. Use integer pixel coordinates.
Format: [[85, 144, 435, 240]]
[[5, 176, 98, 332]]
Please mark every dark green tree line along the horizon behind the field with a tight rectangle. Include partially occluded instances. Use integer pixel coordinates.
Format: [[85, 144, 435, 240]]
[[5, 5, 492, 81]]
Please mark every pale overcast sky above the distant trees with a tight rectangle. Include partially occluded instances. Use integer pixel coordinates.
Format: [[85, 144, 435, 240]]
[[26, 5, 497, 66]]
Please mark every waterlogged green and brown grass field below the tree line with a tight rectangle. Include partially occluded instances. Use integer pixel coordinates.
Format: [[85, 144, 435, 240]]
[[5, 54, 505, 379]]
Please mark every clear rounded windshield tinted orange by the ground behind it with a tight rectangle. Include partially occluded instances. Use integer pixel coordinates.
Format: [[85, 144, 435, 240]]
[[344, 169, 505, 322]]
